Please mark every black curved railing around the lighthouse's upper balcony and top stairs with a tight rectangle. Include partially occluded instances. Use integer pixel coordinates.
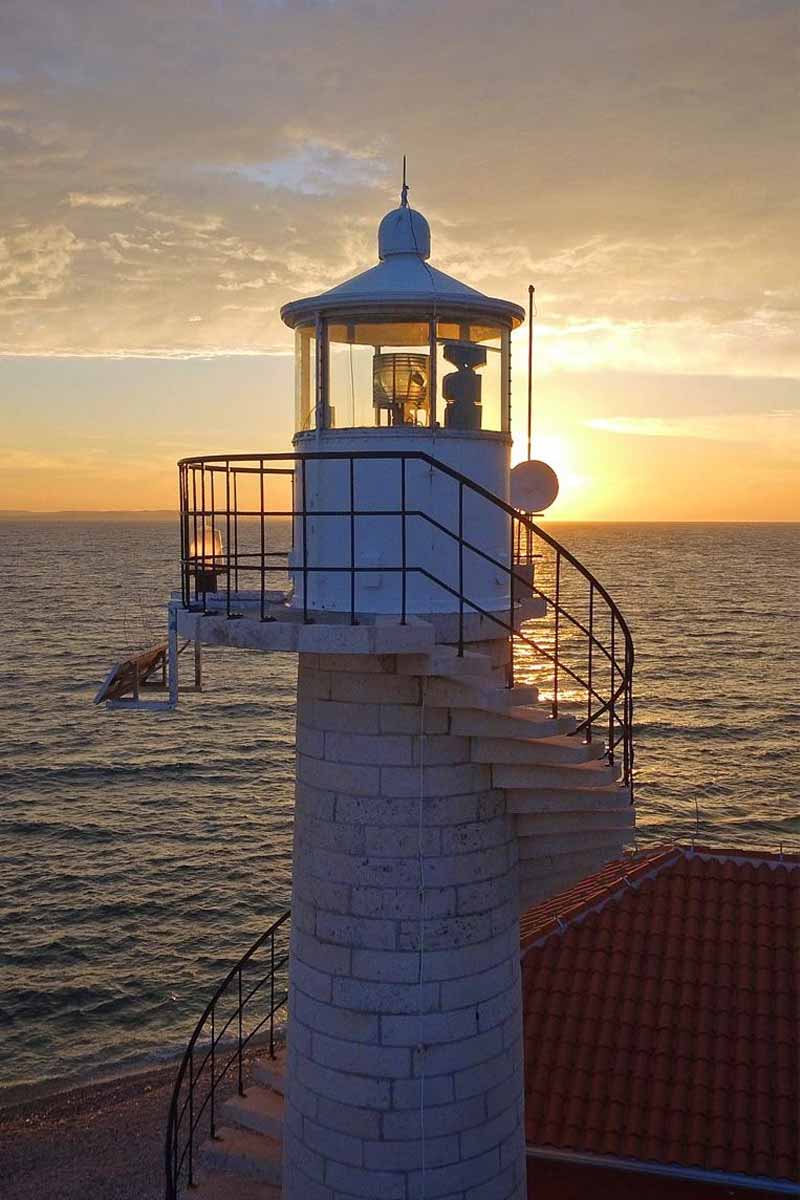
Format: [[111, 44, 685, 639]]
[[179, 450, 633, 798]]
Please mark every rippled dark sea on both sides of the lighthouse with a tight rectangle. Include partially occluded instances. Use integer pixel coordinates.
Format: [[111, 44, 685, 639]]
[[0, 520, 800, 1099]]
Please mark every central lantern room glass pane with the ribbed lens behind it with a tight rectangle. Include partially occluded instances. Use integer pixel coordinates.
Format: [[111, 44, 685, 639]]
[[327, 320, 431, 428]]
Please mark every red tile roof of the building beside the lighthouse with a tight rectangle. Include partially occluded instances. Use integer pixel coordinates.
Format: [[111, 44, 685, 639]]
[[522, 846, 800, 1180]]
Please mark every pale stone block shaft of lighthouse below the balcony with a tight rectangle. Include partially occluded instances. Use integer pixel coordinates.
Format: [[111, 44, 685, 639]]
[[283, 648, 525, 1200]]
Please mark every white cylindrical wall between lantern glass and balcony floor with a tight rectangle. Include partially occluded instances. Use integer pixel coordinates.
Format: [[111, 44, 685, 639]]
[[293, 428, 510, 613]]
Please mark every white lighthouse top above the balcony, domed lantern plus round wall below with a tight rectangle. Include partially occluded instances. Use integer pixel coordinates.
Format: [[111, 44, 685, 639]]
[[282, 187, 524, 614]]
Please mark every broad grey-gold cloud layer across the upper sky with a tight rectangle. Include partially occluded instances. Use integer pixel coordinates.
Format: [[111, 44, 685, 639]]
[[0, 0, 800, 376]]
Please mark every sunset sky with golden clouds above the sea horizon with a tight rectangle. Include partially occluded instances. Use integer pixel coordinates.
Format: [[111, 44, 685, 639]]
[[0, 0, 800, 521]]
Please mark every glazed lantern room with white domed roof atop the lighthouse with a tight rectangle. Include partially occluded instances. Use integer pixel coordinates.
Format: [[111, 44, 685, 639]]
[[282, 194, 524, 445]]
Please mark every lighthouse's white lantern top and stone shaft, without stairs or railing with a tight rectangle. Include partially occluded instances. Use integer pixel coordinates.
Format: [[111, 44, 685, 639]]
[[282, 194, 525, 1200]]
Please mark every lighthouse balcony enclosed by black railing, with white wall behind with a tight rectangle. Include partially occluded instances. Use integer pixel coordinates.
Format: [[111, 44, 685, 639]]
[[170, 450, 633, 787]]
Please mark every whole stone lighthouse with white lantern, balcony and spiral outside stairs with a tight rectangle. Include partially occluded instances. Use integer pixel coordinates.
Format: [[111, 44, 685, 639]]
[[154, 180, 633, 1200]]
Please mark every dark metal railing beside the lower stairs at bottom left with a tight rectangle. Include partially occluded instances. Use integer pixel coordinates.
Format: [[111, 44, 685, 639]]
[[164, 912, 289, 1200]]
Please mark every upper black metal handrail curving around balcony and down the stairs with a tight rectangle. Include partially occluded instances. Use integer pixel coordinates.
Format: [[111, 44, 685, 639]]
[[179, 450, 633, 798]]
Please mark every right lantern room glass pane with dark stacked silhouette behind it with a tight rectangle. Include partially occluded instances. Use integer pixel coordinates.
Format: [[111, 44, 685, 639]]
[[437, 320, 510, 433]]
